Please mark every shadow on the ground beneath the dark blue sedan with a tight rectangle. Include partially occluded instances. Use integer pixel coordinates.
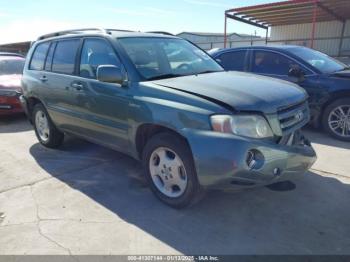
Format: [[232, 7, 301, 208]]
[[303, 127, 350, 149]]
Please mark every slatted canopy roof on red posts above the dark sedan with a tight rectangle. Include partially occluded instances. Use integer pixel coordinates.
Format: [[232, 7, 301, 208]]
[[226, 0, 350, 28]]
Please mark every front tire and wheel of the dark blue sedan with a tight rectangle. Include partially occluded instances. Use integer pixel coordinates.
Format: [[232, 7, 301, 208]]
[[322, 98, 350, 142]]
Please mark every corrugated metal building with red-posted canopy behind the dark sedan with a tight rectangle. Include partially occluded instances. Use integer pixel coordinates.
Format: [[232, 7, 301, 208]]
[[225, 0, 350, 56]]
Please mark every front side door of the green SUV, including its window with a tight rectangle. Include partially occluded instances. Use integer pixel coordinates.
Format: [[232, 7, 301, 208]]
[[72, 38, 130, 150]]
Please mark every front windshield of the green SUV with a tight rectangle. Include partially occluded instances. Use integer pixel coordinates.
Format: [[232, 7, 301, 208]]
[[119, 37, 223, 80]]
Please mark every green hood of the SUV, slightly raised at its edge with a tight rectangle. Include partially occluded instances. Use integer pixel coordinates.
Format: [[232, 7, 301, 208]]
[[153, 72, 307, 114]]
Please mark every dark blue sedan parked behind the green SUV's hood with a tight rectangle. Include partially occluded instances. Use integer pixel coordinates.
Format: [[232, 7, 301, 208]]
[[209, 45, 350, 141]]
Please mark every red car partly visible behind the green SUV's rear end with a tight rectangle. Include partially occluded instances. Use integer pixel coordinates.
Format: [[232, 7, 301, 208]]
[[0, 52, 25, 116]]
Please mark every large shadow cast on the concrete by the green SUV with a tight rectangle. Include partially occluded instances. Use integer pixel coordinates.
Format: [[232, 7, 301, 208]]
[[30, 138, 350, 255]]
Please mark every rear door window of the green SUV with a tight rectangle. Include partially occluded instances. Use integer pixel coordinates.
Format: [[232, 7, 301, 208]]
[[52, 39, 80, 75]]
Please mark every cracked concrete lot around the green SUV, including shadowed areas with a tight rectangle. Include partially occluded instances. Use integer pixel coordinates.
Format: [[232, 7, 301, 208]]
[[0, 115, 350, 254]]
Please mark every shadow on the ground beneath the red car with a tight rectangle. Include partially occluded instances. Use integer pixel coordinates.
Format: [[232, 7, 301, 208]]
[[0, 114, 33, 133]]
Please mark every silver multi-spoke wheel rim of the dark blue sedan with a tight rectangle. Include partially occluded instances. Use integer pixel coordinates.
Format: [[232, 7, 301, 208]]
[[328, 105, 350, 138]]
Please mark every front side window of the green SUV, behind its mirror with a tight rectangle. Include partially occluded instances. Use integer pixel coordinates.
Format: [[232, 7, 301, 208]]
[[80, 39, 120, 79]]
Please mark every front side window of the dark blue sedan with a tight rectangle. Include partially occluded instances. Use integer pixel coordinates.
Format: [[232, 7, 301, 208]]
[[253, 51, 300, 75]]
